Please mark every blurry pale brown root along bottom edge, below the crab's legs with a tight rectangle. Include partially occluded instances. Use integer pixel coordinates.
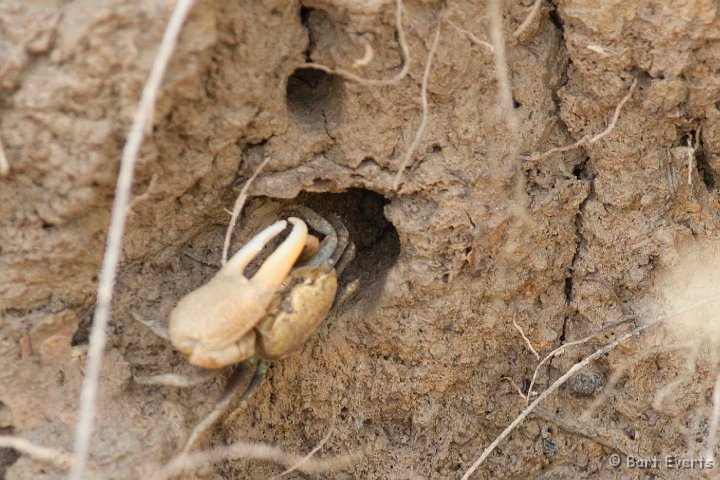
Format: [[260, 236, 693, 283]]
[[152, 442, 362, 480]]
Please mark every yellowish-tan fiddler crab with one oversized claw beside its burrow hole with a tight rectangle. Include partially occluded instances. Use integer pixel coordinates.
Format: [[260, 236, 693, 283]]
[[135, 206, 356, 451]]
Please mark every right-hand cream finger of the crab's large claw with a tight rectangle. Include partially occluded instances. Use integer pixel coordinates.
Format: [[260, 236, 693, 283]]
[[250, 217, 307, 295]]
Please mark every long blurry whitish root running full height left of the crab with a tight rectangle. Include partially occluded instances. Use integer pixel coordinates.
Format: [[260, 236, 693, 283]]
[[69, 0, 193, 480]]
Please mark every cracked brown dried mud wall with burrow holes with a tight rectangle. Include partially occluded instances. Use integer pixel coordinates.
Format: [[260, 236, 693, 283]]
[[0, 0, 720, 479]]
